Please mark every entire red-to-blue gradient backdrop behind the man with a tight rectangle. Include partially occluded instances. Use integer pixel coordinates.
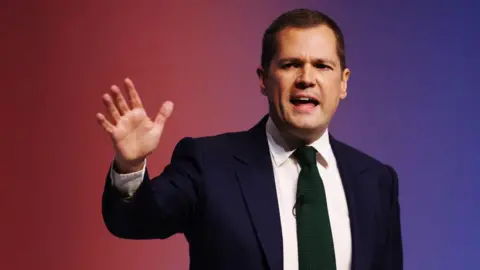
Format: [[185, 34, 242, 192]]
[[0, 0, 480, 270]]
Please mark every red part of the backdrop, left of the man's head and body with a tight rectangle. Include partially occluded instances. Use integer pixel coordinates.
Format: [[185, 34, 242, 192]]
[[0, 1, 288, 270]]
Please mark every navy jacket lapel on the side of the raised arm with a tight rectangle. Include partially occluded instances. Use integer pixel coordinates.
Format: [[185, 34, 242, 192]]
[[235, 117, 283, 270]]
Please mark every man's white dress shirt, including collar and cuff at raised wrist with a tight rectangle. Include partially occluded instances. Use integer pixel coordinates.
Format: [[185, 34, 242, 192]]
[[111, 118, 352, 270]]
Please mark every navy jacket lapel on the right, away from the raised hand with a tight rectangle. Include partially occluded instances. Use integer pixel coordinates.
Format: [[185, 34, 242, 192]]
[[330, 136, 374, 270]]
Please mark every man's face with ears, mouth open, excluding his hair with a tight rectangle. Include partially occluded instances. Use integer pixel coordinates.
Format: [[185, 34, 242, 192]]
[[258, 25, 350, 140]]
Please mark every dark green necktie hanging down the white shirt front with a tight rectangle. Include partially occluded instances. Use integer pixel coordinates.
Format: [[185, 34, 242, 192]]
[[294, 146, 336, 270]]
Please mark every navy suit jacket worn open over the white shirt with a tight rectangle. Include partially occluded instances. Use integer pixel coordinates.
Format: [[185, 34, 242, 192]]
[[102, 117, 403, 270]]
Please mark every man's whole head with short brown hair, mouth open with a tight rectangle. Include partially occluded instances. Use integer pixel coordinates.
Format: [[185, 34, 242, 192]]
[[257, 9, 350, 142]]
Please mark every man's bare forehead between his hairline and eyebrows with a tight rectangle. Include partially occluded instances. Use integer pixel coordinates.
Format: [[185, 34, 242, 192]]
[[276, 25, 338, 61]]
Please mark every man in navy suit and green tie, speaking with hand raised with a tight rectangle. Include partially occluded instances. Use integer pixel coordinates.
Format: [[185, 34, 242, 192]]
[[97, 9, 403, 270]]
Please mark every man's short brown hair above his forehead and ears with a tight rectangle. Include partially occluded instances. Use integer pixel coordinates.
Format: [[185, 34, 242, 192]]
[[261, 9, 346, 71]]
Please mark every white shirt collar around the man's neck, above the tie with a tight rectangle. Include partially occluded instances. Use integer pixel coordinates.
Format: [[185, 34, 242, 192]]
[[266, 117, 334, 167]]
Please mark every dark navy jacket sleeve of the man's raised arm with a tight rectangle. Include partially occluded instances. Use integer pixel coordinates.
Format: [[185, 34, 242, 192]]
[[102, 138, 201, 239]]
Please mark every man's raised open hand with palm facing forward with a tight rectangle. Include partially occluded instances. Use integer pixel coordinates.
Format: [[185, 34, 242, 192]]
[[97, 78, 173, 173]]
